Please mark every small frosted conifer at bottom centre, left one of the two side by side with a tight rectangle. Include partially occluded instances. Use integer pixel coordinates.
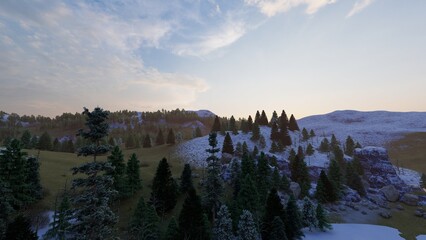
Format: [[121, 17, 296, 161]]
[[212, 205, 234, 240]]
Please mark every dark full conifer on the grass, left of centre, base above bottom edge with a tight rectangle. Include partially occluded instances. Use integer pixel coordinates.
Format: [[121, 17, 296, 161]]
[[150, 158, 178, 215]]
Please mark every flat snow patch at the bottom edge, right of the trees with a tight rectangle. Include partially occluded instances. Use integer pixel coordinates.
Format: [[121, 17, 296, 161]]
[[304, 224, 404, 240]]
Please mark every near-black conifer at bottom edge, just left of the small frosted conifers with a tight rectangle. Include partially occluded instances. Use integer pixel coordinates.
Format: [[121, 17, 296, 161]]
[[179, 189, 209, 239]]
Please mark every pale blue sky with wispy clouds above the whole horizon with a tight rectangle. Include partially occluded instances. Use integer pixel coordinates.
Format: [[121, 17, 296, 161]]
[[0, 0, 426, 118]]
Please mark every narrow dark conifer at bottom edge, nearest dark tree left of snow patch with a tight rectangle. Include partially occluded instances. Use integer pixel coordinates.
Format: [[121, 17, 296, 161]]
[[285, 195, 305, 239]]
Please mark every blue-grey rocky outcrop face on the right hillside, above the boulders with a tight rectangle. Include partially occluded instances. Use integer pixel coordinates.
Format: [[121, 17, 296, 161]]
[[355, 147, 410, 192]]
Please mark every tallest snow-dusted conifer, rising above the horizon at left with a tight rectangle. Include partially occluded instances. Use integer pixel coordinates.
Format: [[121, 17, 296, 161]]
[[69, 107, 117, 239]]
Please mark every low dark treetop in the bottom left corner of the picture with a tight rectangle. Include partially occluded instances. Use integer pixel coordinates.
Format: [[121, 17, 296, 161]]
[[6, 215, 38, 240]]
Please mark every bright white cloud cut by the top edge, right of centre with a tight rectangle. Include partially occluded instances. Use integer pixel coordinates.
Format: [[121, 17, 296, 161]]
[[245, 0, 337, 17]]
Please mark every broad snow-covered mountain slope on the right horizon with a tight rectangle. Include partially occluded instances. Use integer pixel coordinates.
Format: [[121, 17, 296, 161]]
[[298, 110, 426, 146]]
